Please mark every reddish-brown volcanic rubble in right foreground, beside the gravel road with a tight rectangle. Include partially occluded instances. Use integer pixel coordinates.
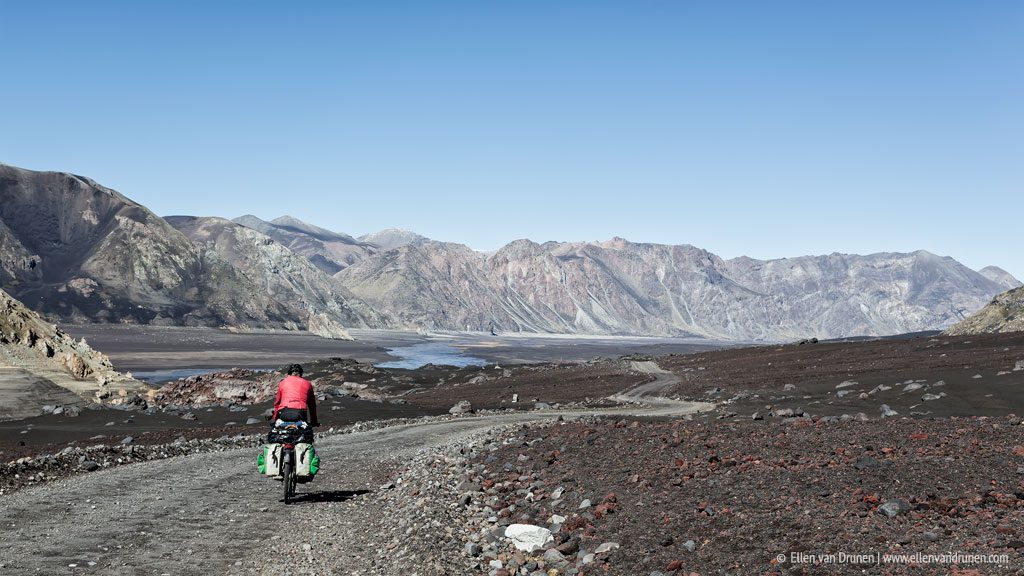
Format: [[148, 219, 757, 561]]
[[461, 416, 1024, 575]]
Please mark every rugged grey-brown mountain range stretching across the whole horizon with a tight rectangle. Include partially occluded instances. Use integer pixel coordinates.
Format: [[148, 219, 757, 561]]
[[0, 159, 1020, 340]]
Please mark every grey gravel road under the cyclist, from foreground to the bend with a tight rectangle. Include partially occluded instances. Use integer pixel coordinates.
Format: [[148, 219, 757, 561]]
[[0, 366, 711, 575]]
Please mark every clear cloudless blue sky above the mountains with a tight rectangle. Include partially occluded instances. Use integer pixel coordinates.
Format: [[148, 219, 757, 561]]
[[0, 1, 1024, 279]]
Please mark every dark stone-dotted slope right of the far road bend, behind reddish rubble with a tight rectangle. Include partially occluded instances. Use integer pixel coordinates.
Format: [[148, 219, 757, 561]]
[[657, 332, 1024, 418]]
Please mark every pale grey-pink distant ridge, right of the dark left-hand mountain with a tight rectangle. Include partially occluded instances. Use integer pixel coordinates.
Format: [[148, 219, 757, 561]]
[[336, 238, 1000, 340]]
